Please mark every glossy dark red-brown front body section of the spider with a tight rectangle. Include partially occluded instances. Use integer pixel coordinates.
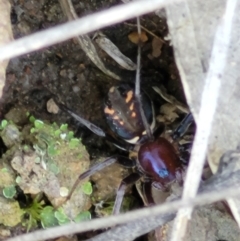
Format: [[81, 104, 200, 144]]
[[138, 137, 181, 186]]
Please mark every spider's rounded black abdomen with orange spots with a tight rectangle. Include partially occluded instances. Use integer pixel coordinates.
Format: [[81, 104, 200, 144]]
[[104, 84, 155, 144]]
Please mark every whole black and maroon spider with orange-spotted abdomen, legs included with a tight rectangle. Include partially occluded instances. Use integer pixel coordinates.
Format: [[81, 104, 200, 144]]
[[60, 84, 193, 214]]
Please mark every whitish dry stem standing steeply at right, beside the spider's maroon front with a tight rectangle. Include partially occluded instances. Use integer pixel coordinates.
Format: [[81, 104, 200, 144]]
[[171, 0, 237, 241]]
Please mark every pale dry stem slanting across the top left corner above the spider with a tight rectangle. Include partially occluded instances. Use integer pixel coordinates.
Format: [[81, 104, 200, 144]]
[[0, 0, 181, 60]]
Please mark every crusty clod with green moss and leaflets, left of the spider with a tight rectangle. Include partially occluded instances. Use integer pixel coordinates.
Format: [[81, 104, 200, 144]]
[[0, 113, 92, 231]]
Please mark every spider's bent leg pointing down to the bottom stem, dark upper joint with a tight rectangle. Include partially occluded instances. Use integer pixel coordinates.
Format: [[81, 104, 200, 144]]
[[112, 173, 141, 215]]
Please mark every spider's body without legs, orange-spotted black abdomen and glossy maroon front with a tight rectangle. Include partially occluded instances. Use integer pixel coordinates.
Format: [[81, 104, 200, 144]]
[[104, 84, 182, 187]]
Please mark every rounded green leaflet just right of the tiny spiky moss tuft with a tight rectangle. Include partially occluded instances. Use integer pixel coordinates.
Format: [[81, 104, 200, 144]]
[[40, 206, 58, 228]]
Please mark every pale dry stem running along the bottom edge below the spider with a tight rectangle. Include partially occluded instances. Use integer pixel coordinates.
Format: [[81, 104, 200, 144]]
[[7, 170, 240, 241]]
